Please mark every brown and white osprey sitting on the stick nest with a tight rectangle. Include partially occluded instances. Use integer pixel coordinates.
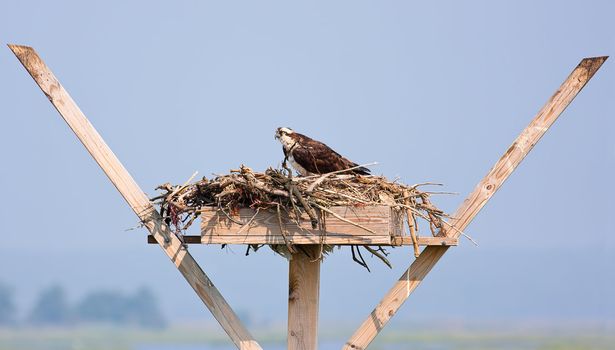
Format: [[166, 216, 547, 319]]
[[275, 128, 370, 176]]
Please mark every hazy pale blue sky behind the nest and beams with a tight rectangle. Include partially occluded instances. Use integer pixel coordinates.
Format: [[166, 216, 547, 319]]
[[0, 1, 615, 340]]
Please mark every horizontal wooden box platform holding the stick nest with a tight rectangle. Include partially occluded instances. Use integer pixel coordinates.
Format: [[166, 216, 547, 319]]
[[148, 205, 458, 246]]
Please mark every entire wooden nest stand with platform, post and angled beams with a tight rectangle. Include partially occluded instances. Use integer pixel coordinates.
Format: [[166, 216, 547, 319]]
[[9, 45, 607, 350]]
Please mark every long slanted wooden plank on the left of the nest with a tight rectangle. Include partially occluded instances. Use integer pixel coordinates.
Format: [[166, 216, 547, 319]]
[[9, 45, 261, 349]]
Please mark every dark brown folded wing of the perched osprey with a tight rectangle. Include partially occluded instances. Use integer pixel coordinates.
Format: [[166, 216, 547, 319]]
[[291, 133, 369, 175]]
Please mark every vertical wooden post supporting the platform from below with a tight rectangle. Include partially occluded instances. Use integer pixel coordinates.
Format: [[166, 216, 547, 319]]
[[288, 245, 320, 350]]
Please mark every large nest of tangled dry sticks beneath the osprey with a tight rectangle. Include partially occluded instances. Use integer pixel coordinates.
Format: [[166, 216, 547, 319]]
[[152, 165, 447, 270]]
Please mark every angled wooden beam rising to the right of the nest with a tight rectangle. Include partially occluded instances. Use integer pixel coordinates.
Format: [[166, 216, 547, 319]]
[[344, 56, 607, 349]]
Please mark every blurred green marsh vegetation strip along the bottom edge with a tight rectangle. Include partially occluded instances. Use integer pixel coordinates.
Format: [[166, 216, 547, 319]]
[[0, 326, 615, 350]]
